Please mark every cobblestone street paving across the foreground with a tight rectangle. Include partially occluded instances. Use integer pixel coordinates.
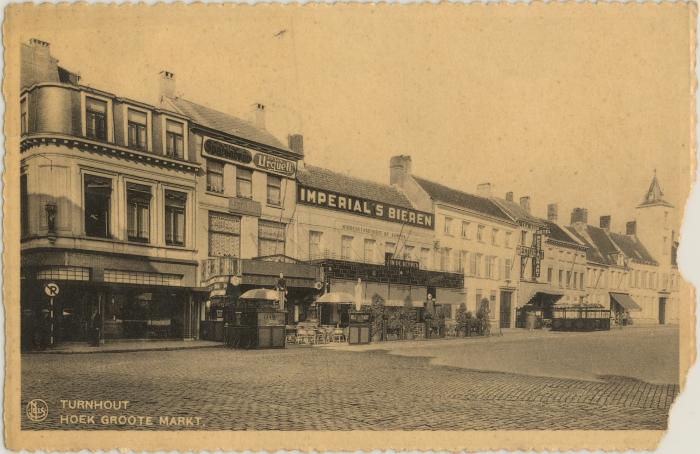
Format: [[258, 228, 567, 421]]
[[22, 328, 678, 430]]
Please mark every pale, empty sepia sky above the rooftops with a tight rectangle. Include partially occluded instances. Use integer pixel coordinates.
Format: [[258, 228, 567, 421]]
[[17, 4, 691, 234]]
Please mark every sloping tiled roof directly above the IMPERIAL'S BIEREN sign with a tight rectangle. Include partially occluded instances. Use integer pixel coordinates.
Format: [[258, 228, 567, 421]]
[[297, 164, 413, 208]]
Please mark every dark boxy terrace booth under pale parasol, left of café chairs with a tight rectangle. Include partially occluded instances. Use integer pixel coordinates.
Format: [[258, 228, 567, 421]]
[[224, 289, 286, 349]]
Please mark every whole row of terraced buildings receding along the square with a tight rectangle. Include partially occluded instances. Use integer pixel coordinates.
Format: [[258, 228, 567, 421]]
[[17, 40, 679, 348]]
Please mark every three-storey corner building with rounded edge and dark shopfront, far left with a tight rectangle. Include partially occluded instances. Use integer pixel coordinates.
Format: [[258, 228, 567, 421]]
[[19, 40, 206, 346]]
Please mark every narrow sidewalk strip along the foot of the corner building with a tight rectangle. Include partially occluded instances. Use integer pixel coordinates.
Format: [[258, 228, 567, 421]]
[[23, 340, 224, 355]]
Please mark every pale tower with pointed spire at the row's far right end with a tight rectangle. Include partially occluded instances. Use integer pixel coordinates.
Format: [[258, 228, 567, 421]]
[[628, 171, 678, 268]]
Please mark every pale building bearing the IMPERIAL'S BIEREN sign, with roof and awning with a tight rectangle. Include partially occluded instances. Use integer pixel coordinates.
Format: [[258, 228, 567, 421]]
[[290, 161, 463, 326]]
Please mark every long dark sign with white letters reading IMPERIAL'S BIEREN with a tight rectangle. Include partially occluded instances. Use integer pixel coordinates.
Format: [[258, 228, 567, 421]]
[[297, 185, 434, 229]]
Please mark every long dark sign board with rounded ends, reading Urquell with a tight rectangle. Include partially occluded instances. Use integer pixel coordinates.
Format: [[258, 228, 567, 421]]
[[202, 137, 297, 178]]
